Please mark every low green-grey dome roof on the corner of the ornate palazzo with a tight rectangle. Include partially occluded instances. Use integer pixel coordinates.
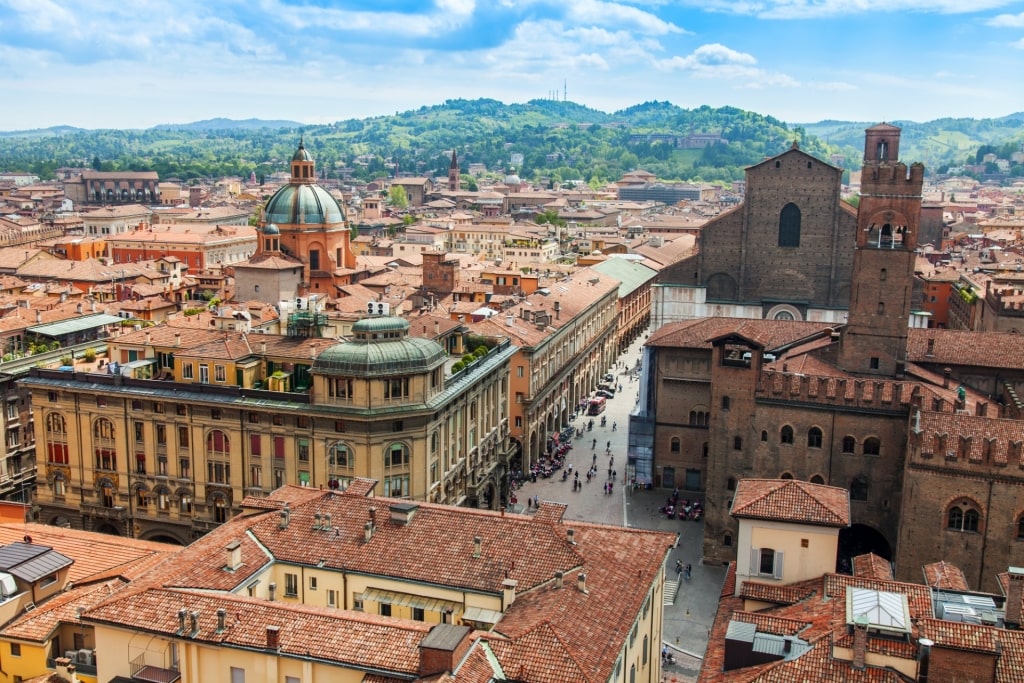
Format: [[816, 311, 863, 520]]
[[310, 316, 447, 377]]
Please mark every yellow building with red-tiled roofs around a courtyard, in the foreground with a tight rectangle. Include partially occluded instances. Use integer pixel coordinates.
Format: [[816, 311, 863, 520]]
[[82, 479, 676, 683]]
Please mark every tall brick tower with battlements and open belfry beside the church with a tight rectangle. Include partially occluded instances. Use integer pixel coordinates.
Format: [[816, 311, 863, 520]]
[[839, 123, 925, 377]]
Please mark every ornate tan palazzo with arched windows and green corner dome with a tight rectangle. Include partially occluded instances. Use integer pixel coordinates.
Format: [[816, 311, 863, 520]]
[[24, 316, 515, 544]]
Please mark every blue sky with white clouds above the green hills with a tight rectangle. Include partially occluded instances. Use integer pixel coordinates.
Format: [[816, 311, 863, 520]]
[[0, 0, 1024, 130]]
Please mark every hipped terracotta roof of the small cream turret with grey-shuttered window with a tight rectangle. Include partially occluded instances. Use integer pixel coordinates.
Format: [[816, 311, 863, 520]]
[[731, 479, 850, 526]]
